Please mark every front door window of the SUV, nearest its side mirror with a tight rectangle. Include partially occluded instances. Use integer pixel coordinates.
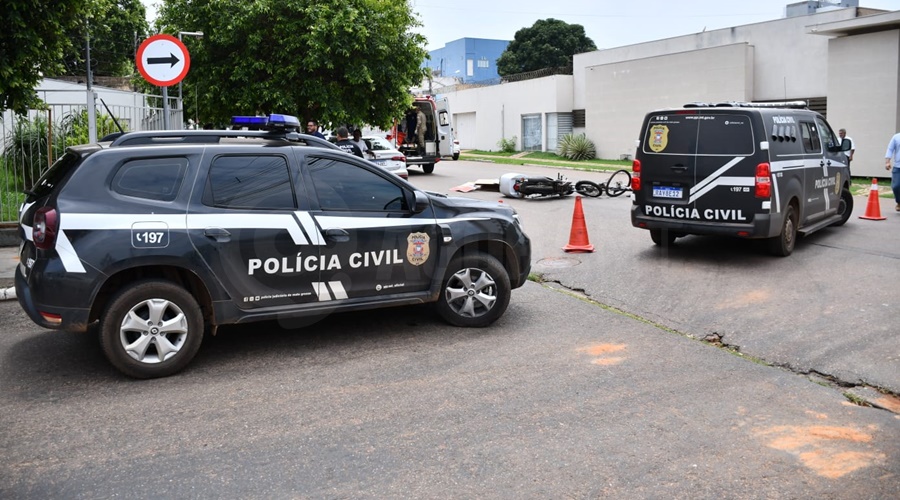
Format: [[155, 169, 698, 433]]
[[309, 157, 409, 212]]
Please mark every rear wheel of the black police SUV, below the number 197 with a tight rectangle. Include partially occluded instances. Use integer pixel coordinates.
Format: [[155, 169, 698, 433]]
[[100, 280, 203, 379]]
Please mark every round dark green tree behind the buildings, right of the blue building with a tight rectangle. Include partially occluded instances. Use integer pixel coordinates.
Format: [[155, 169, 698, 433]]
[[497, 19, 597, 76]]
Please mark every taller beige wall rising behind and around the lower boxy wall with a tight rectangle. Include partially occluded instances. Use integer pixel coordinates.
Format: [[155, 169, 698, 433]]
[[573, 8, 856, 109]]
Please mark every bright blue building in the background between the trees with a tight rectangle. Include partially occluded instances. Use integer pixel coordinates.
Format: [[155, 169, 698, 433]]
[[422, 38, 509, 83]]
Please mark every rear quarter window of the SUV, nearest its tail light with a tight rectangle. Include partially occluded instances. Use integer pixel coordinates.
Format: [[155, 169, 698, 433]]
[[112, 158, 188, 201]]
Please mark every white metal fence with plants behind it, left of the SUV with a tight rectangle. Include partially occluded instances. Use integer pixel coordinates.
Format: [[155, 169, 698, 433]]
[[0, 89, 176, 224]]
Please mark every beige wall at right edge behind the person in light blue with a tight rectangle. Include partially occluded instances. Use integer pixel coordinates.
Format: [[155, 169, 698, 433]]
[[828, 30, 900, 177]]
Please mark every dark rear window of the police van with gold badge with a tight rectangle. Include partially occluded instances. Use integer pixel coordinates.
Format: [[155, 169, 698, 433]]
[[642, 114, 755, 156]]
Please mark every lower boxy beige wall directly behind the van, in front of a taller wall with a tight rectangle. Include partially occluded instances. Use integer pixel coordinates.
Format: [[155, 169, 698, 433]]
[[585, 43, 754, 159]]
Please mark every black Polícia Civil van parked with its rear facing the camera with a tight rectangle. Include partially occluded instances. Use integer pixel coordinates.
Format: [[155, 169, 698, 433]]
[[631, 101, 853, 256]]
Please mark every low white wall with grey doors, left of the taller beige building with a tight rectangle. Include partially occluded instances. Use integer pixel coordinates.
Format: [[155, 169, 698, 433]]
[[441, 75, 573, 151]]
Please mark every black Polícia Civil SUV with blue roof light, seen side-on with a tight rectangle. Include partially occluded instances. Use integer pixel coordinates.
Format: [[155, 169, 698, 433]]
[[15, 115, 531, 378]]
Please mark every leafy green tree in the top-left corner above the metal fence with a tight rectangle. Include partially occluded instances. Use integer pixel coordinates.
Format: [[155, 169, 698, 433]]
[[0, 0, 88, 114]]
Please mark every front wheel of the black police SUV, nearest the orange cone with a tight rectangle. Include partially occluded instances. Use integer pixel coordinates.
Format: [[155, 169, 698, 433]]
[[437, 252, 512, 328]]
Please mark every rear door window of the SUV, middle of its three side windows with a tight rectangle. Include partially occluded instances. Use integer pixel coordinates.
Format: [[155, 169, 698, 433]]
[[203, 155, 297, 210]]
